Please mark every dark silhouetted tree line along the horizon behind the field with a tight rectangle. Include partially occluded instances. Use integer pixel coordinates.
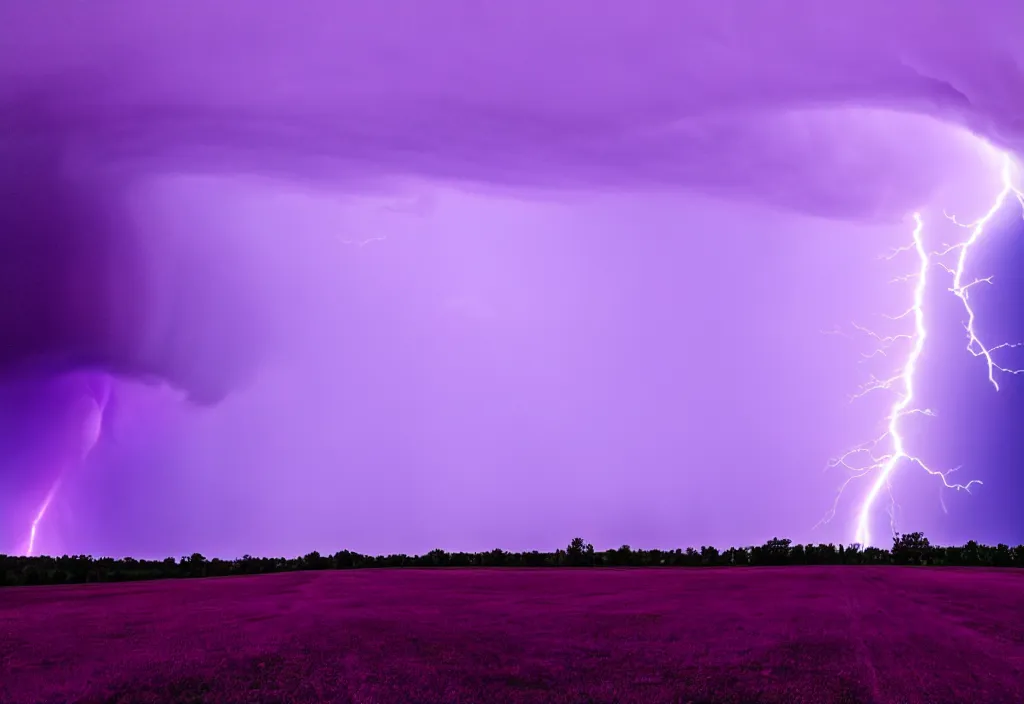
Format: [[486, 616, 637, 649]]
[[0, 532, 1024, 586]]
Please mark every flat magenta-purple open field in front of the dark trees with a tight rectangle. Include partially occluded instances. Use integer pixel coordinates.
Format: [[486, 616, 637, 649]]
[[0, 567, 1024, 704]]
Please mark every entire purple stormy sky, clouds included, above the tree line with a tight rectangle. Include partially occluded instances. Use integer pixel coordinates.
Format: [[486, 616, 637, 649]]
[[0, 0, 1024, 557]]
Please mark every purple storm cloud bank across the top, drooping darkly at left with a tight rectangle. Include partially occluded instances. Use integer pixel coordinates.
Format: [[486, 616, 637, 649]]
[[0, 0, 1024, 413]]
